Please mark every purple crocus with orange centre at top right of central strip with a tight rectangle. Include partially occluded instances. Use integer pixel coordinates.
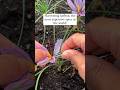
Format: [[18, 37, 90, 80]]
[[67, 0, 85, 16]]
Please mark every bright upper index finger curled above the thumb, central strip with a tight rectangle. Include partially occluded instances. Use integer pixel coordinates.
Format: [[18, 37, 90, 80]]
[[61, 33, 85, 52]]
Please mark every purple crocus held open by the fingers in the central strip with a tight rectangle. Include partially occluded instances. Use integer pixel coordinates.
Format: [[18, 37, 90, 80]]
[[35, 39, 63, 67]]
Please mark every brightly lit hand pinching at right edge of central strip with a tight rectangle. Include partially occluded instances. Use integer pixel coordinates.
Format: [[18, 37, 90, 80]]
[[61, 33, 85, 79]]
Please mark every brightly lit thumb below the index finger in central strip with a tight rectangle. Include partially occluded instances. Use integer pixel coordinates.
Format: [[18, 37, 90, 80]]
[[62, 49, 85, 80]]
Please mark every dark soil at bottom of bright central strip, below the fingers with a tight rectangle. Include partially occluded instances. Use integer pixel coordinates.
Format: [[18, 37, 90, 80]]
[[40, 64, 84, 90]]
